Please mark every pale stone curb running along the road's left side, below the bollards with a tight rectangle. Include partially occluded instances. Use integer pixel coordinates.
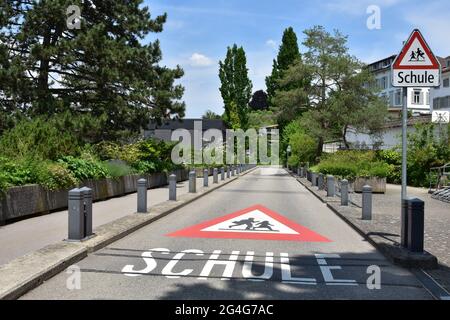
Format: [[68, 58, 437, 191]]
[[0, 166, 258, 300]]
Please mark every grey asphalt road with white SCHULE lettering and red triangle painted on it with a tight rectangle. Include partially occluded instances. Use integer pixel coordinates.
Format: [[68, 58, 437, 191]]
[[22, 168, 432, 299]]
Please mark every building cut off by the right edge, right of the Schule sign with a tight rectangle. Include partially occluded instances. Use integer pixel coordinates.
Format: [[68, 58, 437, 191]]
[[430, 56, 450, 111]]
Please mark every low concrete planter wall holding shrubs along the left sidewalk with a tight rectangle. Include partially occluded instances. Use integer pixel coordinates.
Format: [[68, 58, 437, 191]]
[[0, 169, 188, 225]]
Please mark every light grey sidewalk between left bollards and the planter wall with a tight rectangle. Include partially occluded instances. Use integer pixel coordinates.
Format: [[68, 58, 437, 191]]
[[0, 174, 214, 265]]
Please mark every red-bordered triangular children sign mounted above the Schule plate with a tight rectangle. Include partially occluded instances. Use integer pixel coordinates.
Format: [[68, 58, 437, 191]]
[[392, 29, 439, 70]]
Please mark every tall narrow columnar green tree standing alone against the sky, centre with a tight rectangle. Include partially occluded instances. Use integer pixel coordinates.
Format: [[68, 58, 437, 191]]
[[219, 44, 252, 130]]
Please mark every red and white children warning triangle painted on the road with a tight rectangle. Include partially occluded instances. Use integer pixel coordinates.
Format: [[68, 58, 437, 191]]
[[167, 205, 331, 242]]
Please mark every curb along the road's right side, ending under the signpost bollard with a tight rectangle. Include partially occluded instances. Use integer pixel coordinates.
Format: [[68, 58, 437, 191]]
[[288, 171, 438, 269]]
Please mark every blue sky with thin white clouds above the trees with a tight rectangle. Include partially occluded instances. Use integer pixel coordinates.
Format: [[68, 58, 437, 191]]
[[145, 0, 450, 118]]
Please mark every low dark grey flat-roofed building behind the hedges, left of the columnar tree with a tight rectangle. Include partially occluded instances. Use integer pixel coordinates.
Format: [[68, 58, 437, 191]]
[[144, 119, 228, 146]]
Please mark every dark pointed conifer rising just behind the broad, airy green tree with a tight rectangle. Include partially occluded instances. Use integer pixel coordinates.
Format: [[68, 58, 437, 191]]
[[266, 27, 300, 106]]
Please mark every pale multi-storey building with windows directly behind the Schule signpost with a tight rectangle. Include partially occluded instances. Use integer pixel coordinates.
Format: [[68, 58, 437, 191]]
[[368, 55, 431, 114]]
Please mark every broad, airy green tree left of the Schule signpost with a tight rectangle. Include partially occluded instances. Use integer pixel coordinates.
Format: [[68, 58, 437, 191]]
[[275, 26, 387, 156]]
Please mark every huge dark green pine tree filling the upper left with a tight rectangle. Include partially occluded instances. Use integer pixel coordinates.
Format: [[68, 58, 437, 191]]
[[0, 0, 185, 139]]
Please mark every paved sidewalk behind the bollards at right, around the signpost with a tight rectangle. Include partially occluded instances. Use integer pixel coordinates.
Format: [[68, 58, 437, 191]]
[[297, 172, 450, 291]]
